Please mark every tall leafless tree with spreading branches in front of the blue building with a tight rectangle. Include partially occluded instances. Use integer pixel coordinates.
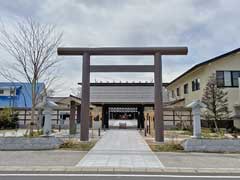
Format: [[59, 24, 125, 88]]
[[0, 18, 62, 132]]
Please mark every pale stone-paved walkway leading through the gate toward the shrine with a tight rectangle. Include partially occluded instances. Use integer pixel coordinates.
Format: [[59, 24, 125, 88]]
[[77, 129, 163, 168]]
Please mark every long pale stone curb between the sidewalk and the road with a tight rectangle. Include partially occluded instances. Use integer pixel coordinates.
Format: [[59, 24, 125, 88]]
[[0, 166, 240, 174]]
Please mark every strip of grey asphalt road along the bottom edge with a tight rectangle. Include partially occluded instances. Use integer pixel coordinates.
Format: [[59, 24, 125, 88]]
[[0, 174, 240, 180]]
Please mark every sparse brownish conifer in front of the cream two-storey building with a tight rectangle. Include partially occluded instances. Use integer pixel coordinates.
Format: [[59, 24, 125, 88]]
[[202, 74, 230, 132]]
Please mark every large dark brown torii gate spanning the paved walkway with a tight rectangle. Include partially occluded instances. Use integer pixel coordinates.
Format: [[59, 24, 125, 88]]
[[57, 47, 188, 142]]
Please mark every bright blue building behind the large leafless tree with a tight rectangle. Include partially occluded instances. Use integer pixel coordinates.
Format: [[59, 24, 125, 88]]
[[0, 82, 45, 109]]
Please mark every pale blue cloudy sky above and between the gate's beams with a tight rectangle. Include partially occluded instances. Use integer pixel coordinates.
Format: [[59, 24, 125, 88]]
[[0, 0, 240, 95]]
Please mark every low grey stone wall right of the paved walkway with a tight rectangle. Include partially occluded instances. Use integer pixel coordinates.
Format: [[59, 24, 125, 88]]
[[182, 139, 240, 152]]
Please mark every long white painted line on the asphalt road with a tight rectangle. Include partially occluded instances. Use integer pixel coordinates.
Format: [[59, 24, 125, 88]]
[[0, 174, 240, 179]]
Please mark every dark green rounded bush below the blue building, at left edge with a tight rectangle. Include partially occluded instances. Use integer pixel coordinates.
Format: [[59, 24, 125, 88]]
[[0, 108, 18, 129]]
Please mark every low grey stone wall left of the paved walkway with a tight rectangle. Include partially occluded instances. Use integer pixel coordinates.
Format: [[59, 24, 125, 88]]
[[0, 137, 63, 150]]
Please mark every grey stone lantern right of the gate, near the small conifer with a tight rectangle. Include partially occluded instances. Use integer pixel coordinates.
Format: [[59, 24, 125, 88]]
[[187, 100, 206, 138]]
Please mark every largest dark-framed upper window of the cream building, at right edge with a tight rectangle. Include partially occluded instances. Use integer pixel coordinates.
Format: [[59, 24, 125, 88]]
[[216, 71, 240, 87]]
